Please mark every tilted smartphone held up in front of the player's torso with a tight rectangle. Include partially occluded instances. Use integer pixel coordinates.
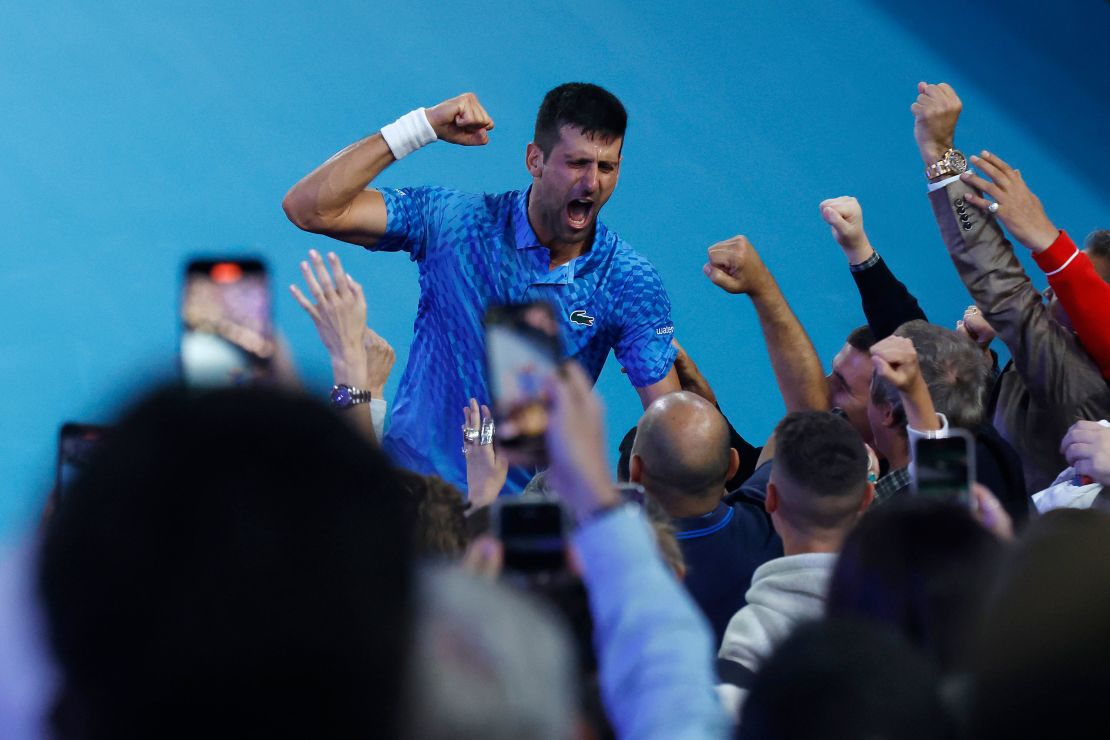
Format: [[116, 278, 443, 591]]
[[484, 302, 563, 464]]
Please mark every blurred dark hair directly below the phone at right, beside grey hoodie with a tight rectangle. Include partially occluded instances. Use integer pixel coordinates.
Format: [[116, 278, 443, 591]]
[[826, 496, 1003, 673]]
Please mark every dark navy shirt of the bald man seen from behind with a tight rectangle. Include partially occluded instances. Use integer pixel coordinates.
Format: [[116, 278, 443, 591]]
[[674, 491, 783, 645]]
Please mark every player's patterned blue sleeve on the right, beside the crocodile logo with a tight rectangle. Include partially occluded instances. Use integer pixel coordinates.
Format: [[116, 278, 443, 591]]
[[614, 257, 678, 388]]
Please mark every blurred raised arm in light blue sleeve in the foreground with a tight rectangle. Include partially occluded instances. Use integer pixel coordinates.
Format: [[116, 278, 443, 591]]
[[547, 363, 728, 740]]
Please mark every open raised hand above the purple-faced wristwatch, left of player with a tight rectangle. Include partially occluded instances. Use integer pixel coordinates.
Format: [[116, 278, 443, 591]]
[[289, 250, 366, 385]]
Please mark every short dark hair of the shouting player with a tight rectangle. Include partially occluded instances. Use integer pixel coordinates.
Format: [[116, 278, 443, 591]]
[[534, 82, 628, 160]]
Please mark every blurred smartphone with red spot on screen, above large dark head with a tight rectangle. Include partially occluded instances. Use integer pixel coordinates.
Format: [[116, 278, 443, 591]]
[[180, 259, 274, 387]]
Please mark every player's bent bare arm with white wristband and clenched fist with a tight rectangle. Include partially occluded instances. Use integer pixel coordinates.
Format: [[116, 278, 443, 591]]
[[282, 92, 493, 246]]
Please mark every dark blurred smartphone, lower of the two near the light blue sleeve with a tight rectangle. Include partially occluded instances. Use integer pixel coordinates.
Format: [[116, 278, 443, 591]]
[[491, 496, 569, 574]]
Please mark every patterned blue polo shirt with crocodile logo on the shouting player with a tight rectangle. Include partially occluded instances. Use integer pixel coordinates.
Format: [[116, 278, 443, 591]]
[[373, 186, 676, 491]]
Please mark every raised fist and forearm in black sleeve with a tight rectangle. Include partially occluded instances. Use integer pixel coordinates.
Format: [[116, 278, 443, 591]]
[[819, 195, 928, 339]]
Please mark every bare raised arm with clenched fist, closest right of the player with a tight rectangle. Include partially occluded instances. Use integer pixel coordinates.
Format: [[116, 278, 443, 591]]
[[704, 236, 829, 413]]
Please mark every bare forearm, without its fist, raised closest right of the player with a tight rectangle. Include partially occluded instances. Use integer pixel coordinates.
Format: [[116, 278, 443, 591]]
[[751, 280, 828, 412]]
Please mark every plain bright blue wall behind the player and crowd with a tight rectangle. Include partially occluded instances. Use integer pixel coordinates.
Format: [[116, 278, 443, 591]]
[[0, 0, 1110, 543]]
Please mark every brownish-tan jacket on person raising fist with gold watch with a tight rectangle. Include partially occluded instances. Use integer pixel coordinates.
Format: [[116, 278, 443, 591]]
[[929, 181, 1110, 493]]
